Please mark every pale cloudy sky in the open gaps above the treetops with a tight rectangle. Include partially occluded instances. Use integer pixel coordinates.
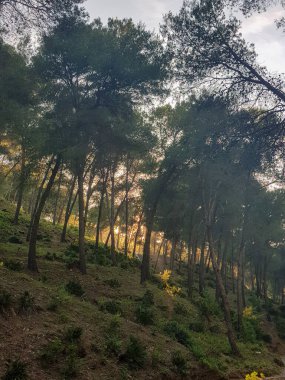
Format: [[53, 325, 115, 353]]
[[85, 0, 285, 73]]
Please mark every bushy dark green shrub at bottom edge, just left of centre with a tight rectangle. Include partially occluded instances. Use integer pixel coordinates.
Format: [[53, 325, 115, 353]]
[[123, 335, 147, 369]]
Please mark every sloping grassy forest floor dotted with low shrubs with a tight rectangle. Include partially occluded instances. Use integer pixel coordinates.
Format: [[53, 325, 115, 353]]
[[0, 201, 285, 380]]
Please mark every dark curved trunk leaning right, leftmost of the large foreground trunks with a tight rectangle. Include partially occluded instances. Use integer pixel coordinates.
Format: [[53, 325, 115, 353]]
[[28, 156, 61, 272]]
